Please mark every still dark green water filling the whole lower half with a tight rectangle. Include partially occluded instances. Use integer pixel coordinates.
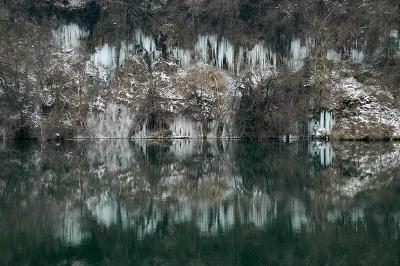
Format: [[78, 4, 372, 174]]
[[0, 140, 400, 265]]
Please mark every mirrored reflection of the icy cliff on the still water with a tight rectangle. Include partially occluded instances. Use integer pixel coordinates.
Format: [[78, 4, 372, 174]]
[[0, 140, 400, 264]]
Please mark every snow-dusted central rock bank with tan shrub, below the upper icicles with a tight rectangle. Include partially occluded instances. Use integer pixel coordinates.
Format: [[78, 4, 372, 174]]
[[80, 55, 238, 138]]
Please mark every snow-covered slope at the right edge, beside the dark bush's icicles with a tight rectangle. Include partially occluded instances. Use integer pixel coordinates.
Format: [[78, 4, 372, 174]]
[[330, 71, 400, 140]]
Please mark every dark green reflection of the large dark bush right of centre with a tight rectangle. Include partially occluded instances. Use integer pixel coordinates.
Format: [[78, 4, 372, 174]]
[[235, 142, 313, 194]]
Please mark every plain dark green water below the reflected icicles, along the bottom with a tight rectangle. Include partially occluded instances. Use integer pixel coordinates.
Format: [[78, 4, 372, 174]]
[[0, 196, 399, 265]]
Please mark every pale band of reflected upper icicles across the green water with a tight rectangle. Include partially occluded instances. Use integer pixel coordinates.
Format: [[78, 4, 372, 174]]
[[82, 191, 280, 239]]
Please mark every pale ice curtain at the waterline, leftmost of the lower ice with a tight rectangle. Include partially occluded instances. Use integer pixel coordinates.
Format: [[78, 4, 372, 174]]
[[86, 104, 133, 138]]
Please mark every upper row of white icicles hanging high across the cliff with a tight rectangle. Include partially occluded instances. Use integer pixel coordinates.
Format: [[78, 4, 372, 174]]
[[53, 24, 364, 74]]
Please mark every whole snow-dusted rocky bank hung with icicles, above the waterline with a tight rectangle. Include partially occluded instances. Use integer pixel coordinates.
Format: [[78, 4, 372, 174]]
[[0, 0, 400, 140]]
